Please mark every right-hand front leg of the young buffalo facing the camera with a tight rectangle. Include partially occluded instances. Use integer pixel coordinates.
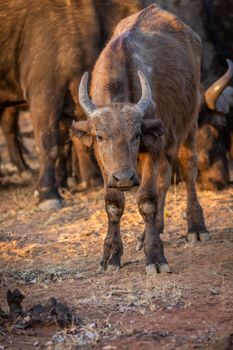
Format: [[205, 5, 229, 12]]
[[137, 153, 170, 273]]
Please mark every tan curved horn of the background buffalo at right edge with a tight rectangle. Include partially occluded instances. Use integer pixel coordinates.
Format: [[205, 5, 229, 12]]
[[205, 60, 233, 110]]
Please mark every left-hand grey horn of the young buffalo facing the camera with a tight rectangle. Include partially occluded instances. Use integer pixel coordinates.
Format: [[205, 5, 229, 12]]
[[78, 72, 97, 117]]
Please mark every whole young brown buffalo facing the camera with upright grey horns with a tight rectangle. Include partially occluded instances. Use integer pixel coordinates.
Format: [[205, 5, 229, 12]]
[[73, 5, 209, 273]]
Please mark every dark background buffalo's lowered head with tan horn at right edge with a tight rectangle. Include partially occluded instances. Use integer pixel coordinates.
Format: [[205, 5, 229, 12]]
[[197, 60, 233, 190]]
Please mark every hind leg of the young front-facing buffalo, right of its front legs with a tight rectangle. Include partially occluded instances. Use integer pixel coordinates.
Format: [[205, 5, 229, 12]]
[[179, 128, 209, 242]]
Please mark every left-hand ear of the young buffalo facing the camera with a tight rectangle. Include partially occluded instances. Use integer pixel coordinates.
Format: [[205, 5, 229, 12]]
[[70, 120, 93, 147]]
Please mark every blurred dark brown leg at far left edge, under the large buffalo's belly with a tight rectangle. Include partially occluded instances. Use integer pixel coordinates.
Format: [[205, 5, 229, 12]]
[[0, 107, 30, 172]]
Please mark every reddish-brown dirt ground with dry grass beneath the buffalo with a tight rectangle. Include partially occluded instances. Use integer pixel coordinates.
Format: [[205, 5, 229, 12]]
[[0, 121, 233, 350]]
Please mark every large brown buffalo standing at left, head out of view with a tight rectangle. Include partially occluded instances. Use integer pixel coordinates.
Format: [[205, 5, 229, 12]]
[[0, 0, 100, 209]]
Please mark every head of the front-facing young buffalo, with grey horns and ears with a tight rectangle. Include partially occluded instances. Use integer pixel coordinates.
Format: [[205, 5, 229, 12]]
[[73, 71, 164, 191]]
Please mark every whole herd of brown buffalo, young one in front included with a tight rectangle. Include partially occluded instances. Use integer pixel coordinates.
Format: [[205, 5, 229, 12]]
[[0, 0, 233, 272]]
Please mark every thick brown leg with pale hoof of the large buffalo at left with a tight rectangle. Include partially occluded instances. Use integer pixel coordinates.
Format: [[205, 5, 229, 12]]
[[30, 95, 62, 210]]
